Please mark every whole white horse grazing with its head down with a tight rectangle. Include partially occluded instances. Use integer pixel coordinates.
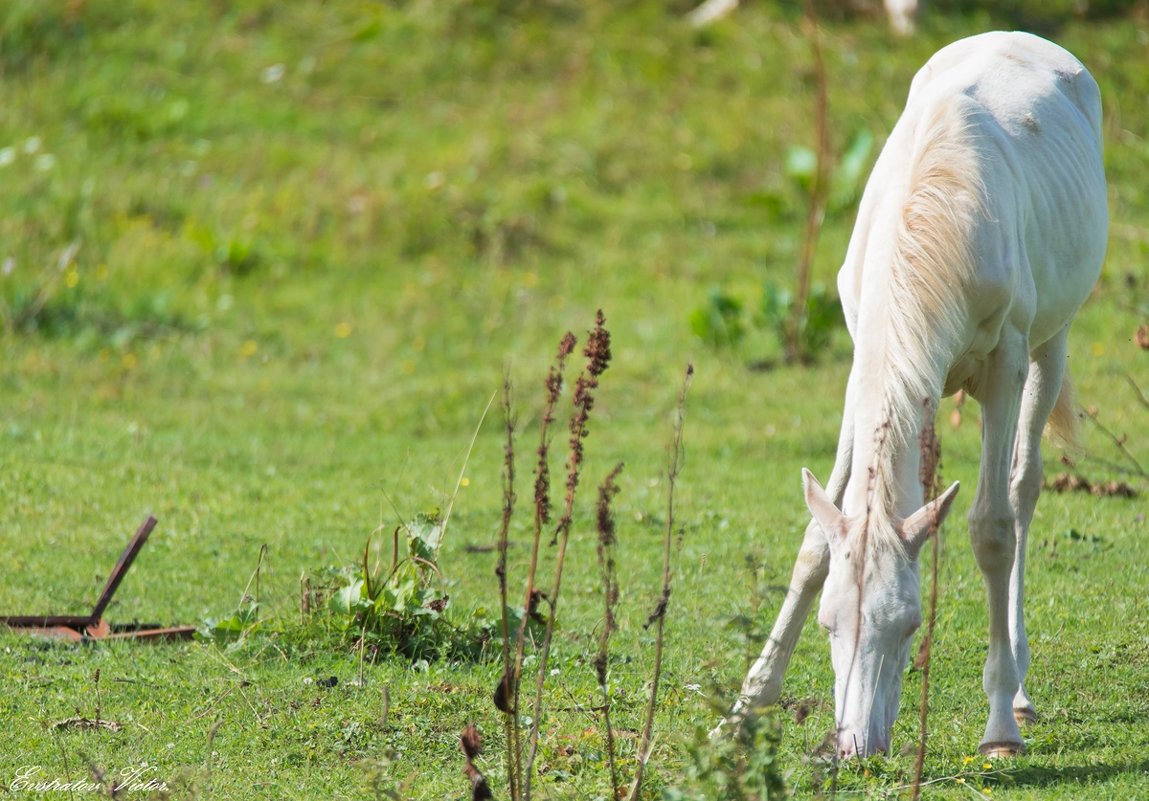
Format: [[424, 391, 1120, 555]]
[[731, 33, 1108, 757]]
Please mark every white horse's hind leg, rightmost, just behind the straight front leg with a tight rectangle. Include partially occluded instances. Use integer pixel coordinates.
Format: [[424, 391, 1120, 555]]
[[1009, 330, 1069, 725]]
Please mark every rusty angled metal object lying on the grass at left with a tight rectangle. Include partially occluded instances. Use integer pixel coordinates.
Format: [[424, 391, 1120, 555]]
[[0, 515, 195, 642]]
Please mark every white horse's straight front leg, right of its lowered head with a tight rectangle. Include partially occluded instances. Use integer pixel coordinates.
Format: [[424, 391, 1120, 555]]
[[970, 332, 1028, 756]]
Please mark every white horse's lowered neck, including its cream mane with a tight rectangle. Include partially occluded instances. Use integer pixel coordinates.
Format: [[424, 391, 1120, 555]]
[[842, 98, 985, 530]]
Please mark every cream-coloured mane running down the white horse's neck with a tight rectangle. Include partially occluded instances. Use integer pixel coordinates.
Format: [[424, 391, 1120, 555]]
[[858, 95, 985, 549]]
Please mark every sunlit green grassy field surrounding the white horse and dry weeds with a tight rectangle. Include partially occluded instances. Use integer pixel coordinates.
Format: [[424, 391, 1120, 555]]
[[0, 0, 1149, 801]]
